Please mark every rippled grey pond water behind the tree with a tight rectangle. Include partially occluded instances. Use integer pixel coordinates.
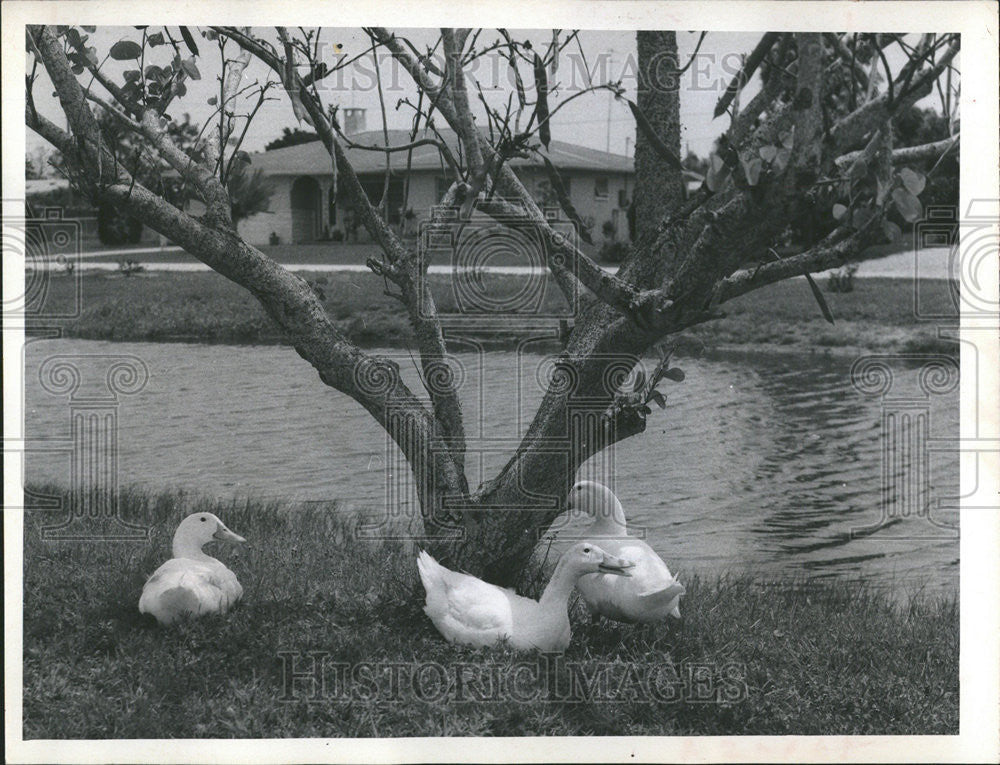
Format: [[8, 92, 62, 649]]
[[25, 339, 959, 592]]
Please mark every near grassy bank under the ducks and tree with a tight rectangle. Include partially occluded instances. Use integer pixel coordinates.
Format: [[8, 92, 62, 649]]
[[24, 491, 958, 738]]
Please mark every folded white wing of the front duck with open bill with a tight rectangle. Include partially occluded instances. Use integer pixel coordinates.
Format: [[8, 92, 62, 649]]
[[417, 551, 513, 646]]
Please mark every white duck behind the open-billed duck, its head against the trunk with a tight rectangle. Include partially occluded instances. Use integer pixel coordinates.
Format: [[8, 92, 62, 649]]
[[567, 481, 684, 622]]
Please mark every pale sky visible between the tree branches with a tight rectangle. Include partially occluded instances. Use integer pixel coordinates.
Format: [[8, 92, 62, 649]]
[[27, 27, 952, 170]]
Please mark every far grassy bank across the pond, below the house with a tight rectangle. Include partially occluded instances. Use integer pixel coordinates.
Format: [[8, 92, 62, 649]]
[[35, 271, 957, 353]]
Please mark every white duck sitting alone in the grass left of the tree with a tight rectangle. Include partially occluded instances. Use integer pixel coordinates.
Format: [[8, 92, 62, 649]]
[[139, 513, 246, 625]]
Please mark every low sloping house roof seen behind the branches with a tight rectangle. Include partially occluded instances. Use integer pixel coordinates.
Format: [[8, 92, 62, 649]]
[[251, 130, 634, 175]]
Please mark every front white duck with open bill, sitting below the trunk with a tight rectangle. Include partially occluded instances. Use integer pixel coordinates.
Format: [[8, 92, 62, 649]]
[[417, 542, 632, 652]]
